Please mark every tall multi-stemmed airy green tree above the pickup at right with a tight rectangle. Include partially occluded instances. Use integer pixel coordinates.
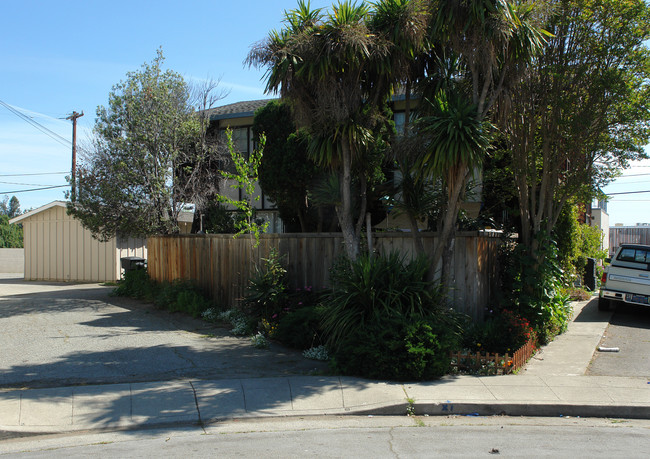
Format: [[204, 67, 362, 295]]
[[502, 0, 650, 255]]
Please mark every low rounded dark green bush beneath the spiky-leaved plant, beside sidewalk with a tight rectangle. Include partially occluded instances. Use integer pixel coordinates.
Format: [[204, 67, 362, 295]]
[[330, 316, 459, 381]]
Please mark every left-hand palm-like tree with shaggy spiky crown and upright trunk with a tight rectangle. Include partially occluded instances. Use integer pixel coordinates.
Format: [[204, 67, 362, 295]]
[[247, 1, 426, 260]]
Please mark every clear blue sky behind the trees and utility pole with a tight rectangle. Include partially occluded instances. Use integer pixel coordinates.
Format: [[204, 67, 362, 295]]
[[0, 0, 650, 224]]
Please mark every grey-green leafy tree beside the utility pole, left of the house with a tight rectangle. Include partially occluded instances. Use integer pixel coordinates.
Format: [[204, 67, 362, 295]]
[[68, 50, 225, 240]]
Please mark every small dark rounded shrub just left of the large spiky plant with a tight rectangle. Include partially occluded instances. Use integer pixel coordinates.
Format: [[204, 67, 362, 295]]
[[273, 306, 326, 350]]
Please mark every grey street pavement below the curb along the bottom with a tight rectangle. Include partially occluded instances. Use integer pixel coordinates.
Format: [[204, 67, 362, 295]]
[[0, 416, 650, 458]]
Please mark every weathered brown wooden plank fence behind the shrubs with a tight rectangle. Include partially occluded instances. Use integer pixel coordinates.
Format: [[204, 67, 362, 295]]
[[147, 232, 500, 320]]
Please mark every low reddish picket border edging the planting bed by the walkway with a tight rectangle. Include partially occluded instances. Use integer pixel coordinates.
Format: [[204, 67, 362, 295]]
[[450, 339, 536, 376]]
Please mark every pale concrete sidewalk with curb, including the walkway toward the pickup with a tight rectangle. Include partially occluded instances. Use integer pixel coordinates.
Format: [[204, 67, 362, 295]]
[[0, 302, 650, 432]]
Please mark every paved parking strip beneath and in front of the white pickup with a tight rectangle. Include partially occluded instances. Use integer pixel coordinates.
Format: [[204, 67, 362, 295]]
[[587, 305, 650, 378]]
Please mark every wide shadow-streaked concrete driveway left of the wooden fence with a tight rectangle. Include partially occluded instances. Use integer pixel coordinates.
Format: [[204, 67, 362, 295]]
[[0, 275, 324, 388]]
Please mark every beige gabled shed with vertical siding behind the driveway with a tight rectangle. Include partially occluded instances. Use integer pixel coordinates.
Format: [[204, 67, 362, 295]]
[[21, 205, 147, 282]]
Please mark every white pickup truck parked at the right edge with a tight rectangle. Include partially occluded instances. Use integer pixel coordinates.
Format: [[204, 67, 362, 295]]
[[598, 244, 650, 311]]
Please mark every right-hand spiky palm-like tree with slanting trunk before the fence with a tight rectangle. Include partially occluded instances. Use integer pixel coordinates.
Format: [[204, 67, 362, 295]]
[[416, 0, 545, 283]]
